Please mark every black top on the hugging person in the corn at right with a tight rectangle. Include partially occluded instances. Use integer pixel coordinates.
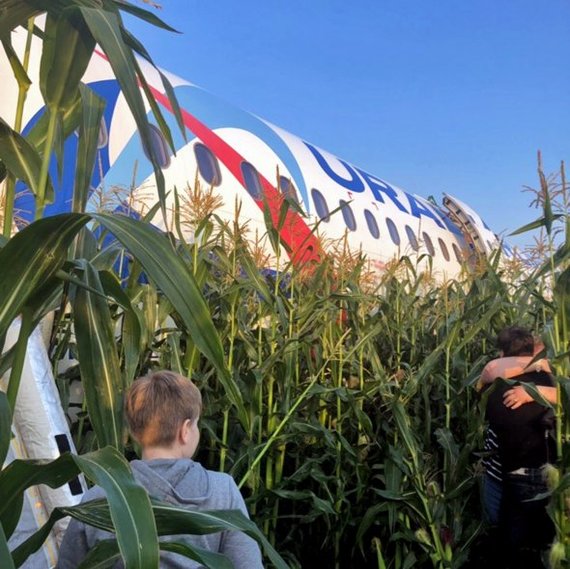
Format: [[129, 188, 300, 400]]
[[486, 372, 554, 472]]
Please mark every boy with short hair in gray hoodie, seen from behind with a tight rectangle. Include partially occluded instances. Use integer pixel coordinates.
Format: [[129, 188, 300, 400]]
[[57, 371, 263, 569]]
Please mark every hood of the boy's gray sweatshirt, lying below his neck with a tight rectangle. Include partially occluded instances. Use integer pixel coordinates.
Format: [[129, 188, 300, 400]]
[[131, 458, 212, 507]]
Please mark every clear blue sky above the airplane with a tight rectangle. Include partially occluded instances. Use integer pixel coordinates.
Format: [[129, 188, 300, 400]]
[[126, 0, 570, 245]]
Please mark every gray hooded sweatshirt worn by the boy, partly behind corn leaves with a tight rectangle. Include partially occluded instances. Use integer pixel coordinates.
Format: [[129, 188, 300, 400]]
[[57, 459, 263, 569]]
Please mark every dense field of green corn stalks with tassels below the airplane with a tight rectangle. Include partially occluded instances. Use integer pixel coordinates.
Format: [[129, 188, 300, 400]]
[[40, 166, 569, 568]]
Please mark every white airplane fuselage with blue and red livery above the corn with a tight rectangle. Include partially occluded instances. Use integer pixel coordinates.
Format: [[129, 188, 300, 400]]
[[0, 28, 499, 278]]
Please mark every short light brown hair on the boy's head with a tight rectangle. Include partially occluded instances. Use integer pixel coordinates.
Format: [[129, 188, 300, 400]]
[[125, 371, 202, 447]]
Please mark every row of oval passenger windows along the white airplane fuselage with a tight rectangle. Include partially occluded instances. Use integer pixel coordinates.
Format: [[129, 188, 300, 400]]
[[153, 136, 463, 263]]
